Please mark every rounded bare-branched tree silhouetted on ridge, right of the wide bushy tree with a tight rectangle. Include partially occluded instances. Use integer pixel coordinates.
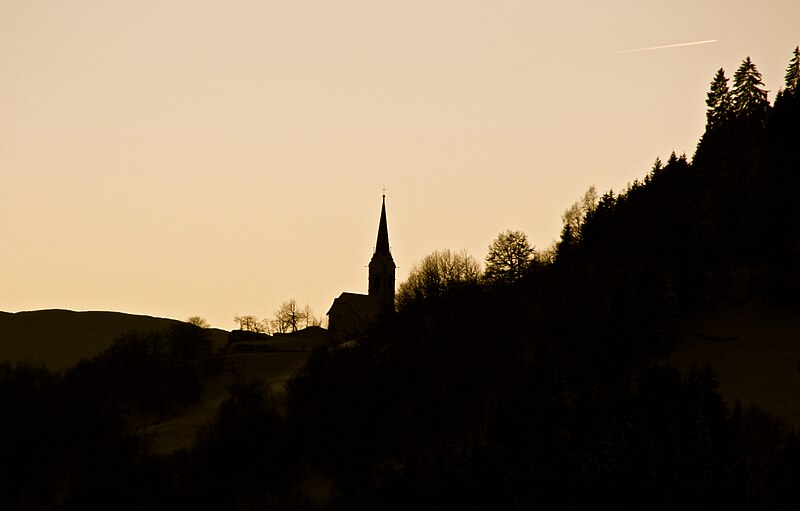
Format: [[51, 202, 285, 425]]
[[484, 230, 535, 283]]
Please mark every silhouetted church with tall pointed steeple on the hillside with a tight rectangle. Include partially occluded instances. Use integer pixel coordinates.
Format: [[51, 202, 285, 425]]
[[328, 195, 397, 344]]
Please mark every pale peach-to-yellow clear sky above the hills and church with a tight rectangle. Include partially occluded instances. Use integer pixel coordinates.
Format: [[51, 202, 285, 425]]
[[0, 0, 800, 329]]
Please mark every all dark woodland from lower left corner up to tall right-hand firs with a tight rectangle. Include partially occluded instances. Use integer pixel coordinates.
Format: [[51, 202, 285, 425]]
[[0, 49, 800, 511]]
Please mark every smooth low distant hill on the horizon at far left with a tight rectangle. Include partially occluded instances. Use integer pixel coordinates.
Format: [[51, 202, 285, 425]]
[[0, 309, 228, 370]]
